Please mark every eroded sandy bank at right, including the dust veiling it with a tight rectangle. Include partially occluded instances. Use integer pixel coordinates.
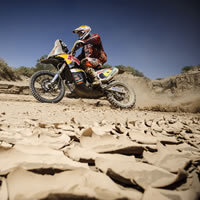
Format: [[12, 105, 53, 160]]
[[117, 68, 200, 113]]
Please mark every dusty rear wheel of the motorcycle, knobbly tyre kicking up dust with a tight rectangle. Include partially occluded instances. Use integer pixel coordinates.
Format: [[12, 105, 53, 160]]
[[107, 81, 136, 108]]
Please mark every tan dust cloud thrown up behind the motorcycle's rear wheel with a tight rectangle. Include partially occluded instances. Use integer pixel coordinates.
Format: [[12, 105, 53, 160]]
[[116, 74, 200, 113]]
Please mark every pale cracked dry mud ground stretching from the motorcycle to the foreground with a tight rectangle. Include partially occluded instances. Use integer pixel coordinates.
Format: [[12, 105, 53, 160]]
[[0, 94, 200, 200]]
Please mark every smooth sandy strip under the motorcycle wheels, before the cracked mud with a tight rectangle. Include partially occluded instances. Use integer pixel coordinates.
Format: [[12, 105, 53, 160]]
[[0, 94, 200, 125]]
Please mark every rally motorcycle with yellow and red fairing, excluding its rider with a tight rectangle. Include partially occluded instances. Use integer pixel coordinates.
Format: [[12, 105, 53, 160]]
[[30, 40, 136, 108]]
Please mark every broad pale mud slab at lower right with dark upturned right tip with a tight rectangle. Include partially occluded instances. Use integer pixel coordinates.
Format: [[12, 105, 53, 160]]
[[95, 155, 187, 189]]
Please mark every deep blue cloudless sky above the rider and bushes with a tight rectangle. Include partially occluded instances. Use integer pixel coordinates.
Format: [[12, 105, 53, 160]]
[[0, 0, 200, 79]]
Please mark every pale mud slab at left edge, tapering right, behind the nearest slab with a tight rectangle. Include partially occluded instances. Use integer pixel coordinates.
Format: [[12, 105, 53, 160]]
[[0, 145, 88, 175]]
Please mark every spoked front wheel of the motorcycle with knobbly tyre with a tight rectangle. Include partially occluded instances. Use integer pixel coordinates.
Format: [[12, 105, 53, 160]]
[[30, 70, 65, 103]]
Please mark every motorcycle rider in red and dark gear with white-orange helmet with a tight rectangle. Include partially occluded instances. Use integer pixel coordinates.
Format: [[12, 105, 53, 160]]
[[73, 25, 107, 86]]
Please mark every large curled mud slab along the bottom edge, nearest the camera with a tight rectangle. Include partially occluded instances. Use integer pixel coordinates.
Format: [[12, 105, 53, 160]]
[[7, 168, 142, 200]]
